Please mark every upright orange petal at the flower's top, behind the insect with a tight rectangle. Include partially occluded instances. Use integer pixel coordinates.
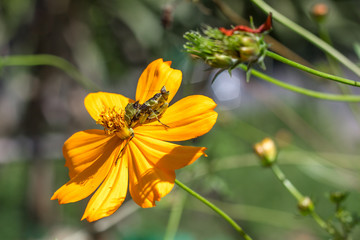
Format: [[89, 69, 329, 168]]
[[136, 59, 182, 103]]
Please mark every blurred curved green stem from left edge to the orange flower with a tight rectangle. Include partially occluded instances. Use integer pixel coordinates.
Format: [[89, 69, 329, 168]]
[[0, 54, 98, 91]]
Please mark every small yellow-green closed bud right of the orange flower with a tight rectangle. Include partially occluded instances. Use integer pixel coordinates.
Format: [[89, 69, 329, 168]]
[[254, 138, 277, 167]]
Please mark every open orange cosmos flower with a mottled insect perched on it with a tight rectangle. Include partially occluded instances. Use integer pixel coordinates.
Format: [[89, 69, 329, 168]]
[[51, 59, 217, 222]]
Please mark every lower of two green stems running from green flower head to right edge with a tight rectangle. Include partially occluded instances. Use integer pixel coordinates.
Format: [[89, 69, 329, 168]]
[[239, 65, 360, 102]]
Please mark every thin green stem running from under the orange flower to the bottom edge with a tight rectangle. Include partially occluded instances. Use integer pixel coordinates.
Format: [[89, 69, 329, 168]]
[[175, 179, 252, 240]]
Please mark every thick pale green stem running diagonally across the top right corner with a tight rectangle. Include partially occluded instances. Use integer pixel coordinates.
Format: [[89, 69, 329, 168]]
[[251, 0, 360, 77]]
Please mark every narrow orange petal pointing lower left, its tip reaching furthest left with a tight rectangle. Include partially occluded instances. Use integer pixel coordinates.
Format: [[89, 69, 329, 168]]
[[51, 134, 123, 204]]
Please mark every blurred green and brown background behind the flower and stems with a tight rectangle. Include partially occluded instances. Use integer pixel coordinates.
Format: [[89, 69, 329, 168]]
[[0, 0, 360, 240]]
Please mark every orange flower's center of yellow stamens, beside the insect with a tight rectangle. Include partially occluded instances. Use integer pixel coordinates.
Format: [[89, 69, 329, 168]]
[[96, 107, 134, 139]]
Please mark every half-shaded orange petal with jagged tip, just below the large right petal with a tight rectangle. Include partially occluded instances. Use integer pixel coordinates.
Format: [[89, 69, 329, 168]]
[[133, 134, 206, 170]]
